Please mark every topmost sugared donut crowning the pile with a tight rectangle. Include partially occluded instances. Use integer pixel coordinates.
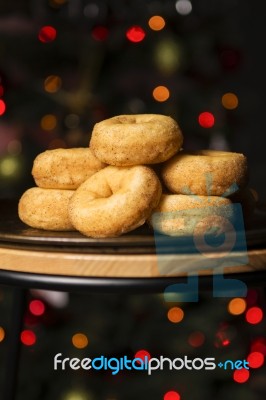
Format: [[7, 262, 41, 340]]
[[90, 114, 183, 167]]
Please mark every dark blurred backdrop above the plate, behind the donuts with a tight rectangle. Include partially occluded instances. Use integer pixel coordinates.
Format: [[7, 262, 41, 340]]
[[0, 0, 266, 200]]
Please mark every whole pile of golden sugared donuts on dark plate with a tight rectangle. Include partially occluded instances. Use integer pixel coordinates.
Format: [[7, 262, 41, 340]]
[[18, 114, 255, 238]]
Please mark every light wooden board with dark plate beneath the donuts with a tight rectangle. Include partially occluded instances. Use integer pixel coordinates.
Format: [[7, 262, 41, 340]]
[[0, 200, 266, 278]]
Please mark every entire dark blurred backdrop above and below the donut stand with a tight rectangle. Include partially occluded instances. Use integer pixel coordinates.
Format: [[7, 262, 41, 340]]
[[0, 0, 266, 400]]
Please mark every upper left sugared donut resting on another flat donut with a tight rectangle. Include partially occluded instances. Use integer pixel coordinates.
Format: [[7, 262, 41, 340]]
[[32, 148, 106, 190]]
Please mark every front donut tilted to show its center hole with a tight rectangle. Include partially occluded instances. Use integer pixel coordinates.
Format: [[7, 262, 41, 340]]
[[69, 166, 161, 238]]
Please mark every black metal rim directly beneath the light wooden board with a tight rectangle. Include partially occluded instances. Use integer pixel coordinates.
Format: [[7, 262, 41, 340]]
[[0, 270, 266, 294]]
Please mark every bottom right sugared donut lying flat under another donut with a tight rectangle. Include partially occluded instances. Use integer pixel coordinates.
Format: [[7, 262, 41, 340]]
[[148, 194, 234, 236]]
